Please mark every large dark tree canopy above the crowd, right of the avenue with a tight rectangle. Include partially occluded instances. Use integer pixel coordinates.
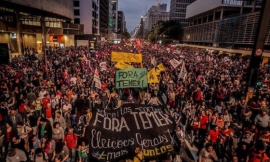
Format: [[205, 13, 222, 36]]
[[147, 20, 182, 42]]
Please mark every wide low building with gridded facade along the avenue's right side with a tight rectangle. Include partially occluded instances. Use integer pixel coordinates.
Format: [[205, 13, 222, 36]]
[[181, 0, 270, 50]]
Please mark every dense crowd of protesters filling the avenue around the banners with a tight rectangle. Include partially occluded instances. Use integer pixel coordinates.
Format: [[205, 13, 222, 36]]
[[0, 40, 270, 162]]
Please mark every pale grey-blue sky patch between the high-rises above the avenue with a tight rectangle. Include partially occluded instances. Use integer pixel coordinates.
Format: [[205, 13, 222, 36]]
[[118, 0, 170, 32]]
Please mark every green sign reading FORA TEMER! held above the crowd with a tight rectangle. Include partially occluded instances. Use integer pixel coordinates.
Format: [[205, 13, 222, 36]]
[[116, 68, 147, 88]]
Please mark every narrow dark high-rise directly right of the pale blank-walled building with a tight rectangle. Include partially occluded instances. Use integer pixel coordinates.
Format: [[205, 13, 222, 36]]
[[99, 0, 113, 40]]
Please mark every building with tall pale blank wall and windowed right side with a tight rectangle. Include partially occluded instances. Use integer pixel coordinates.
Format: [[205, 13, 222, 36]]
[[74, 0, 100, 46]]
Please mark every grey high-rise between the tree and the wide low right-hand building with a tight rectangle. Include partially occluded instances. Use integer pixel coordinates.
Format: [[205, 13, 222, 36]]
[[170, 0, 196, 25]]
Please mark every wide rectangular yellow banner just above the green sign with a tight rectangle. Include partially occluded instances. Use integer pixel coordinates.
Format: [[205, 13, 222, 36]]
[[111, 52, 142, 63]]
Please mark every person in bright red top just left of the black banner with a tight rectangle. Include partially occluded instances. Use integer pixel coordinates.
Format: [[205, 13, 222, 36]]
[[64, 128, 78, 162]]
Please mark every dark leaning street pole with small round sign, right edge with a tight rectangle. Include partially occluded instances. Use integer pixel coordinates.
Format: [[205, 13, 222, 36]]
[[247, 0, 270, 87]]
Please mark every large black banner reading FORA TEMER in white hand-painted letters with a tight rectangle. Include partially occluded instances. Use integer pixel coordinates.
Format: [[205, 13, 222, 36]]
[[86, 104, 175, 162]]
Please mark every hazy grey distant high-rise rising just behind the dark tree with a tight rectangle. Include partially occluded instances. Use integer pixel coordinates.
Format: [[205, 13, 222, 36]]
[[146, 3, 170, 32]]
